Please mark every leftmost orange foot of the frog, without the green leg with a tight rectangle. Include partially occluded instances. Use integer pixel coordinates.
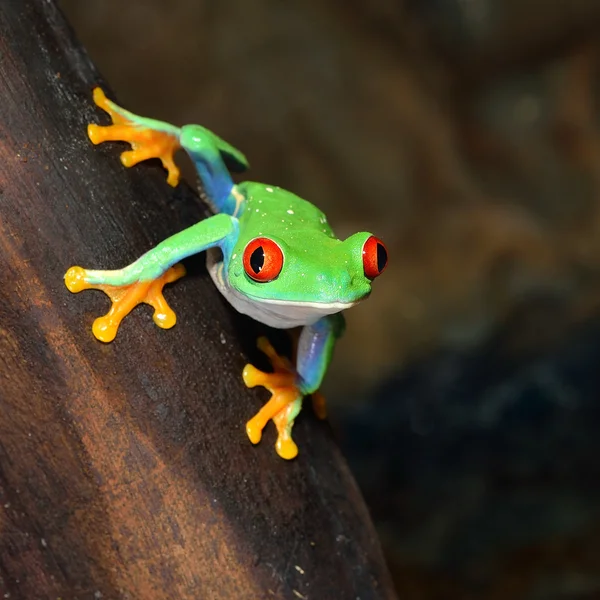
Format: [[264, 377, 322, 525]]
[[65, 264, 185, 342]]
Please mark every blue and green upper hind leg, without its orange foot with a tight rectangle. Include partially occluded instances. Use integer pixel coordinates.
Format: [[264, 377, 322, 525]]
[[179, 125, 248, 217]]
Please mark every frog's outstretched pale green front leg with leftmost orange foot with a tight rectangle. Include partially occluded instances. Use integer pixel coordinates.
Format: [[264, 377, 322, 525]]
[[65, 214, 238, 342]]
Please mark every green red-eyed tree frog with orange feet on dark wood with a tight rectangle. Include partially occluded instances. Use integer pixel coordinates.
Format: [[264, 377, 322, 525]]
[[64, 87, 388, 460]]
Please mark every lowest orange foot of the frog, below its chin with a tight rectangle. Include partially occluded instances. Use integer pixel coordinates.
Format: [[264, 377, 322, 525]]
[[242, 337, 326, 460]]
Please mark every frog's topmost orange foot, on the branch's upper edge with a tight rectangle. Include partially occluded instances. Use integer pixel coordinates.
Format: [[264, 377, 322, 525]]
[[88, 87, 180, 187]]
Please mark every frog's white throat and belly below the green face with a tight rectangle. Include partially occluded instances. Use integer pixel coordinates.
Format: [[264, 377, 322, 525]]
[[206, 249, 355, 329]]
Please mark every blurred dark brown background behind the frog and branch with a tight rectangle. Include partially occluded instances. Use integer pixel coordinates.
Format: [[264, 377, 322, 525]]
[[60, 0, 600, 600]]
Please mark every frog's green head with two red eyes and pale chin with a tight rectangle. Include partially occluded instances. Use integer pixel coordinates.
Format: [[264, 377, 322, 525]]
[[228, 231, 387, 327]]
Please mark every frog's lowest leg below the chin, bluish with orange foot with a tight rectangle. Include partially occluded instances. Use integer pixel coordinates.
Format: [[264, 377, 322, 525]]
[[242, 314, 344, 459]]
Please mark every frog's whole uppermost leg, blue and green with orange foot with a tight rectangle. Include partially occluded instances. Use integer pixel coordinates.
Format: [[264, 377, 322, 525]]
[[88, 88, 248, 216]]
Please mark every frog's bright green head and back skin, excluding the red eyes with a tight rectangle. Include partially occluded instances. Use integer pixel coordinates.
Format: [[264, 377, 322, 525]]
[[227, 182, 371, 304]]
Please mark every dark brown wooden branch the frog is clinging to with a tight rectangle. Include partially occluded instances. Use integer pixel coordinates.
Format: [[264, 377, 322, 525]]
[[0, 0, 395, 600]]
